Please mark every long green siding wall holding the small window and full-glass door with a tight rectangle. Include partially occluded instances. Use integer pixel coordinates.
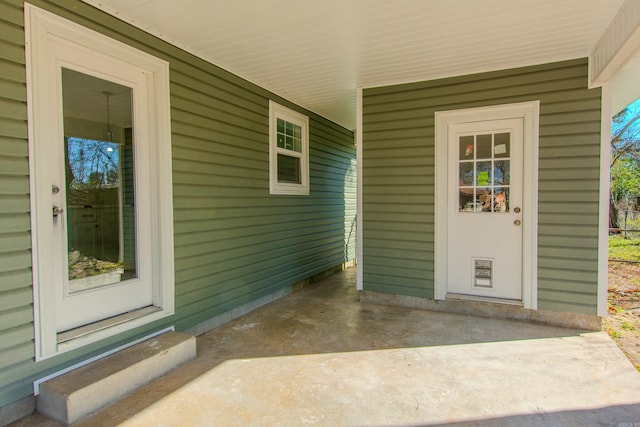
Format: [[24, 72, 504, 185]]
[[0, 0, 356, 407]]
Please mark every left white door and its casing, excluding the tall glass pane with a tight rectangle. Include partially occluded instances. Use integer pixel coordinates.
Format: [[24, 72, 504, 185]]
[[25, 4, 174, 360]]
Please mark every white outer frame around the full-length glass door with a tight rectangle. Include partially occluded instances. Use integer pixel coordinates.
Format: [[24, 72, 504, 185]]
[[25, 3, 175, 361]]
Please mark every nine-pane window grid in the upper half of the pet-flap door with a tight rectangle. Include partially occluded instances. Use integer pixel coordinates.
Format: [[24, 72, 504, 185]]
[[458, 133, 511, 212]]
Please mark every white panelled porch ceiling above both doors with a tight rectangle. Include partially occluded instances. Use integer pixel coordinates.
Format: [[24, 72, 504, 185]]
[[84, 0, 624, 129]]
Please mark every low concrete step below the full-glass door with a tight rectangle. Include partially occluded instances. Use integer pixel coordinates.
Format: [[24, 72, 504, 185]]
[[37, 332, 196, 425]]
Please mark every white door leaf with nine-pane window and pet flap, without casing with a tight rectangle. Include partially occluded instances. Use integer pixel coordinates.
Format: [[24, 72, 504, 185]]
[[447, 118, 523, 301]]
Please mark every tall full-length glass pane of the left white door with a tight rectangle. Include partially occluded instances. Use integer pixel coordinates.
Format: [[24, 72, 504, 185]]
[[62, 68, 137, 293]]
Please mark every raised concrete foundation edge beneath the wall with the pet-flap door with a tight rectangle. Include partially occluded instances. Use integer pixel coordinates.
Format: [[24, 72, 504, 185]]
[[360, 291, 602, 331]]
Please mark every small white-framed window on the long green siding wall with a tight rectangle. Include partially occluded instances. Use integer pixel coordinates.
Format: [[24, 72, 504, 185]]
[[269, 101, 309, 195]]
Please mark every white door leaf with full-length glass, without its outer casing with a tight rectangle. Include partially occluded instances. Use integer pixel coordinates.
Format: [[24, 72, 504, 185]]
[[35, 40, 153, 333]]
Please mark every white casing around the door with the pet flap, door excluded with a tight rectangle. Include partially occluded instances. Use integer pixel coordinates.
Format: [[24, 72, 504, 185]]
[[434, 101, 540, 310]]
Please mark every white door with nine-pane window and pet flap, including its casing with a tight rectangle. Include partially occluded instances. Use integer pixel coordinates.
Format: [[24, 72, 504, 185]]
[[434, 101, 540, 310]]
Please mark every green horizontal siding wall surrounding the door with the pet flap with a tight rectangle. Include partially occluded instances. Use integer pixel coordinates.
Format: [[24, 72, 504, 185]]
[[361, 59, 601, 313]]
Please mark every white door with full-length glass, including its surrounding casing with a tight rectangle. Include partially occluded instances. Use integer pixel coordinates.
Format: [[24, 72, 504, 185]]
[[27, 6, 173, 357]]
